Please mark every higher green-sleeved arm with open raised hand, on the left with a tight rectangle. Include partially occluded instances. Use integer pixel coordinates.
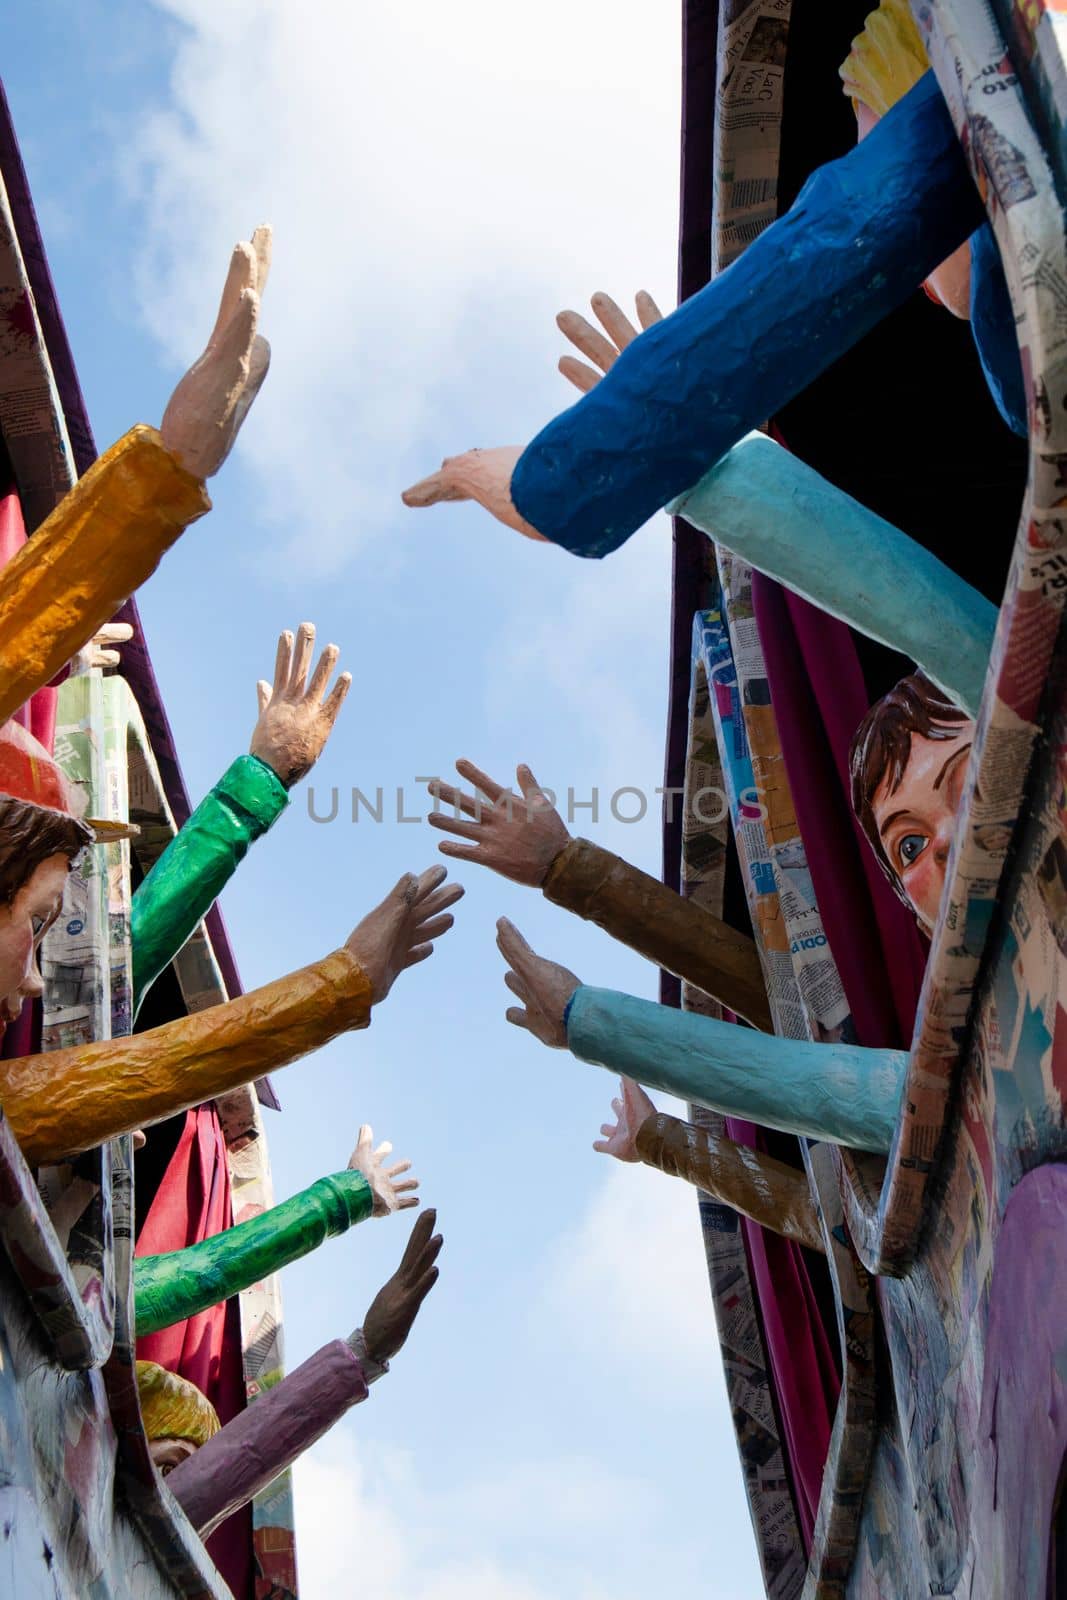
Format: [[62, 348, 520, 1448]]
[[130, 622, 352, 1011]]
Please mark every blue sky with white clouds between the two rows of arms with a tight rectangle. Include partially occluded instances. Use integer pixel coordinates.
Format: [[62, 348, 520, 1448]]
[[3, 0, 760, 1600]]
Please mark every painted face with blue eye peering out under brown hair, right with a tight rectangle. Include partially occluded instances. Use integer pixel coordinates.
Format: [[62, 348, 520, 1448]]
[[870, 722, 974, 933]]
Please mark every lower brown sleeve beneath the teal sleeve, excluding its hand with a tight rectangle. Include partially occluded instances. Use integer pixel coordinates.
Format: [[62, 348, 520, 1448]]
[[637, 1112, 824, 1251]]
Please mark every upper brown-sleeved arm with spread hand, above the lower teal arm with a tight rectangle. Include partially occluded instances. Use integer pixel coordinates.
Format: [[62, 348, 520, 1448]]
[[429, 762, 773, 1032]]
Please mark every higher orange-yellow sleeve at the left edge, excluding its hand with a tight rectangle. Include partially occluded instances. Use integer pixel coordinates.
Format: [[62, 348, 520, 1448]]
[[0, 427, 211, 723]]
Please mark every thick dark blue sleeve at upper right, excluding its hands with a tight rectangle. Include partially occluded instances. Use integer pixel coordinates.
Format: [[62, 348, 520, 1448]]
[[512, 72, 984, 555]]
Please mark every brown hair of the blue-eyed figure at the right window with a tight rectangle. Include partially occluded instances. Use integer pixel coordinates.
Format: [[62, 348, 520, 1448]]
[[848, 672, 971, 904]]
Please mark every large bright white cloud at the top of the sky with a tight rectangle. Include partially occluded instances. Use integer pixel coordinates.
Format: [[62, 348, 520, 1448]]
[[126, 0, 678, 571]]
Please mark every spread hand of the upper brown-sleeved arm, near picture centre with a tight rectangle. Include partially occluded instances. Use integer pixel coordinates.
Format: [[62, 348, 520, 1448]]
[[427, 762, 571, 888]]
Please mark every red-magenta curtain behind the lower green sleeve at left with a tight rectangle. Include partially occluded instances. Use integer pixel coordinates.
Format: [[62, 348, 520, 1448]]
[[134, 1104, 253, 1600]]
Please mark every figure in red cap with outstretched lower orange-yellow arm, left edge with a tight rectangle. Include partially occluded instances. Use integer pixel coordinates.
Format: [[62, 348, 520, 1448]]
[[0, 725, 462, 1165]]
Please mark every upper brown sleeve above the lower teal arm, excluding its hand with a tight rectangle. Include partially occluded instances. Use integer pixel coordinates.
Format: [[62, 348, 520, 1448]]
[[544, 838, 774, 1034]]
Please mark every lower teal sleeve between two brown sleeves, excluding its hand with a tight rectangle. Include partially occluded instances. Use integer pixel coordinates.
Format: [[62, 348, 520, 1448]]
[[566, 986, 907, 1154]]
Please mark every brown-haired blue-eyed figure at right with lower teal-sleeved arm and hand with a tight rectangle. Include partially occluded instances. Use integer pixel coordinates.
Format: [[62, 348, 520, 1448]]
[[486, 674, 974, 1158]]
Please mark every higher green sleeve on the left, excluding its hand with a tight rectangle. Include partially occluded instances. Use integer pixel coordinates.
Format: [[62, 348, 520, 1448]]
[[130, 755, 290, 1014]]
